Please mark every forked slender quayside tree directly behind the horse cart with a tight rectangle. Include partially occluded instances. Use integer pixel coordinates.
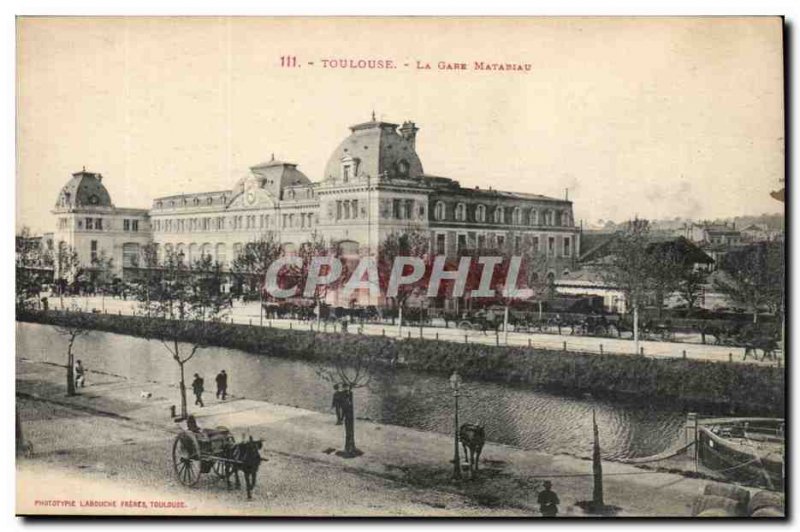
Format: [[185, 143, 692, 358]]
[[136, 251, 230, 419]]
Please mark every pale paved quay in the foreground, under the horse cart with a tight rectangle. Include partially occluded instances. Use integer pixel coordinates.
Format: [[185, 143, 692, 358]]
[[17, 353, 707, 516]]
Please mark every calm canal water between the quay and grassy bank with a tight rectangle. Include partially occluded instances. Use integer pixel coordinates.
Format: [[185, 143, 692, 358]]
[[16, 322, 685, 459]]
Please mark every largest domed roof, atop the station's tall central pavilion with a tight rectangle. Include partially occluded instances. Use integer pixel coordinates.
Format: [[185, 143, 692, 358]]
[[323, 117, 423, 179]]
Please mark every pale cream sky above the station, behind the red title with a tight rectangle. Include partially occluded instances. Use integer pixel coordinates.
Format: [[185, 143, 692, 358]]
[[16, 17, 784, 232]]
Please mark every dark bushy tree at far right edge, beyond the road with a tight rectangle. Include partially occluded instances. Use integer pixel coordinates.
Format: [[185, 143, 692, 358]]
[[714, 242, 785, 323]]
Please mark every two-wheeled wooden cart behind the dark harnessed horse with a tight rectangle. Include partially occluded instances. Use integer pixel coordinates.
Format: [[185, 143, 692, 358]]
[[172, 427, 237, 486]]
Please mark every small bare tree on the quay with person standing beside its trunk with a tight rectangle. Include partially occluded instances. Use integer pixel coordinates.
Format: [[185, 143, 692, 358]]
[[316, 335, 392, 458]]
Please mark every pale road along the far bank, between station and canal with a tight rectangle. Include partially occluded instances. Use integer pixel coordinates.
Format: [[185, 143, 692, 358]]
[[50, 297, 782, 365]]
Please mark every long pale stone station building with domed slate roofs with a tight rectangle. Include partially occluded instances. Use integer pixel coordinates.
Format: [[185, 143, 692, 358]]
[[53, 116, 580, 302]]
